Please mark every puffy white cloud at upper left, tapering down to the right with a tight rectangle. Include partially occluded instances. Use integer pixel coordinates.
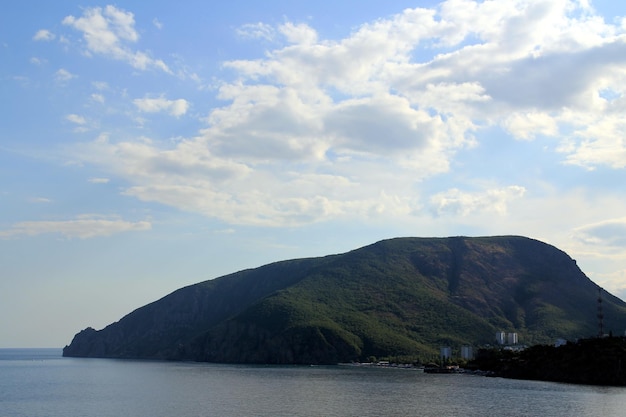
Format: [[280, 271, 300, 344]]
[[63, 5, 171, 73]]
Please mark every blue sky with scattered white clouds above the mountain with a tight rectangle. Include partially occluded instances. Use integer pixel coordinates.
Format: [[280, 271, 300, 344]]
[[0, 0, 626, 347]]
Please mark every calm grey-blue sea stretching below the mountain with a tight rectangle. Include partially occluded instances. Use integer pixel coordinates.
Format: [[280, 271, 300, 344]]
[[0, 349, 626, 417]]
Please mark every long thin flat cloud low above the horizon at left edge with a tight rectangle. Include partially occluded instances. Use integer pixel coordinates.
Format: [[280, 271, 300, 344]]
[[0, 216, 152, 239]]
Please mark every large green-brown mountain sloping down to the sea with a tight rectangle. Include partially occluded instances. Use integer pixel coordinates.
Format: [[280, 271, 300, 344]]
[[63, 236, 626, 364]]
